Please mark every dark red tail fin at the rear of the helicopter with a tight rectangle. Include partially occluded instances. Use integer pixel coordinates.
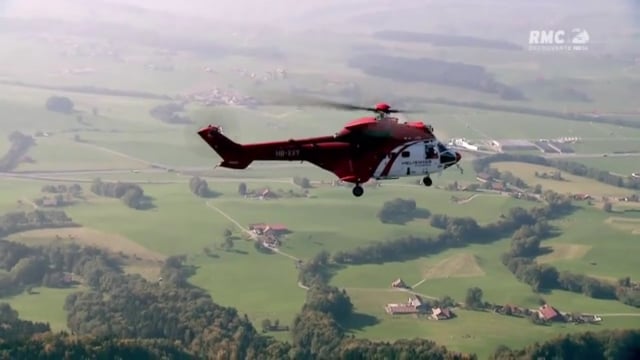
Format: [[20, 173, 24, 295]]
[[198, 125, 253, 169]]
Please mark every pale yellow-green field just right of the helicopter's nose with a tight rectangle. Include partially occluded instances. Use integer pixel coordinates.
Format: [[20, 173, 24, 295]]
[[491, 161, 630, 196]]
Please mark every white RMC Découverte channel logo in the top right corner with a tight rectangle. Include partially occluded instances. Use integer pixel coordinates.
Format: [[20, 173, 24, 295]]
[[529, 28, 589, 51]]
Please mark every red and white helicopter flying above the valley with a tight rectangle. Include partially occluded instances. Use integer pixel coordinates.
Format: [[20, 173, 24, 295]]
[[198, 103, 462, 197]]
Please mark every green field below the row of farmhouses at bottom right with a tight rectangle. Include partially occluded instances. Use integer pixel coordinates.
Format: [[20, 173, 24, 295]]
[[348, 289, 638, 359]]
